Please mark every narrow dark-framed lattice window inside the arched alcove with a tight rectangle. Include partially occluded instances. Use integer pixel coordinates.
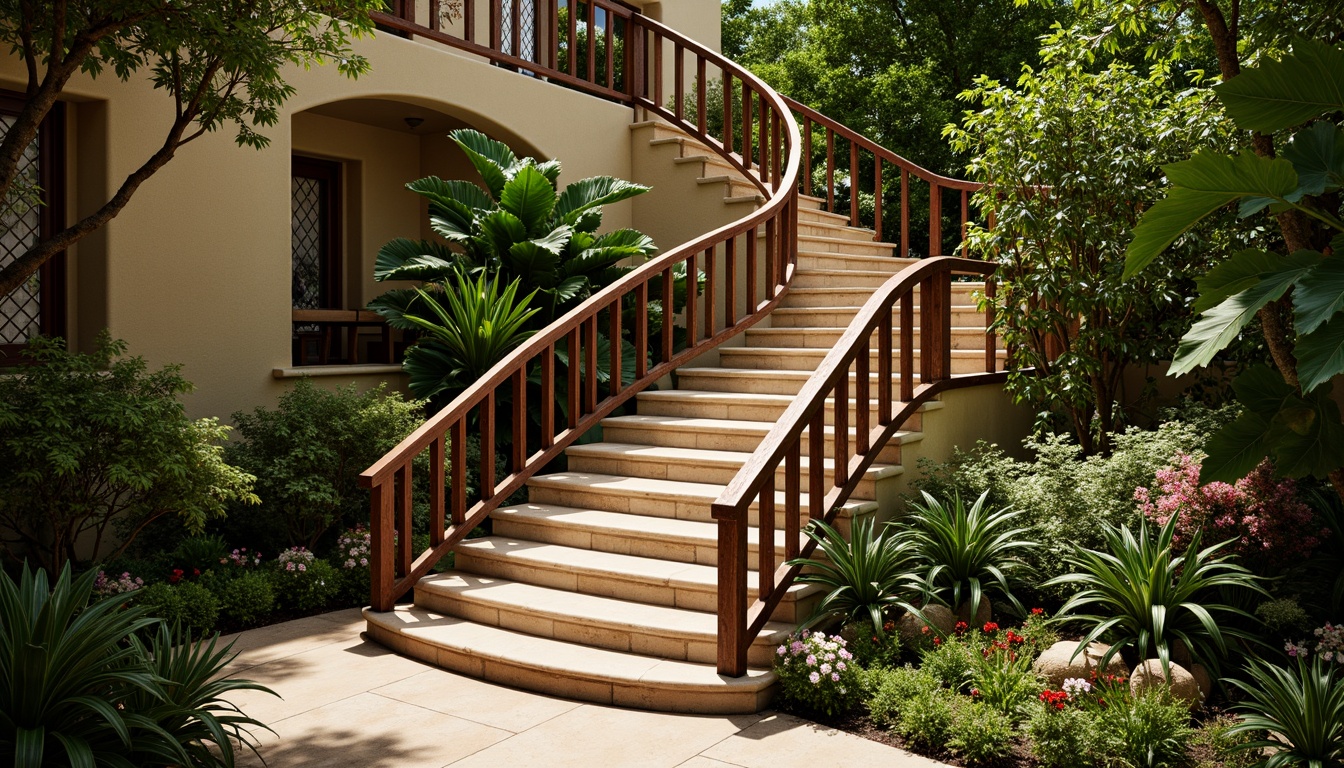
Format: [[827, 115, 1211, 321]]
[[290, 155, 344, 309]]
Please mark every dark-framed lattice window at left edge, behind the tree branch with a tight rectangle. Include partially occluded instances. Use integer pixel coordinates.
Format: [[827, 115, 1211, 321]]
[[0, 90, 66, 366]]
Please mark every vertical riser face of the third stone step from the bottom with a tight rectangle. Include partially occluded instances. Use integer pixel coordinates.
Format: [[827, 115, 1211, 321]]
[[456, 550, 820, 621]]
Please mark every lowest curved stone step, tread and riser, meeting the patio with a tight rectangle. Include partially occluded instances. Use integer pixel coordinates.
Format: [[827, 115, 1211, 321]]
[[364, 607, 777, 714]]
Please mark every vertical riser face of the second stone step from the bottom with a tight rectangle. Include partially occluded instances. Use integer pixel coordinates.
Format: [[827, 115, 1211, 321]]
[[415, 589, 774, 667]]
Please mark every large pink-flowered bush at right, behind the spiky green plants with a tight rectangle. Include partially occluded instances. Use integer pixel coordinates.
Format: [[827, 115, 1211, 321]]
[[1134, 453, 1329, 572]]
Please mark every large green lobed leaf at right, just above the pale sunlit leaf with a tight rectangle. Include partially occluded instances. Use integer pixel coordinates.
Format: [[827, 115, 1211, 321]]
[[1125, 152, 1297, 278]]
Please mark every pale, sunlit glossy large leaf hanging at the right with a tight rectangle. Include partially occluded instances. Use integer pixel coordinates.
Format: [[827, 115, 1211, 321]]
[[1168, 250, 1321, 377]]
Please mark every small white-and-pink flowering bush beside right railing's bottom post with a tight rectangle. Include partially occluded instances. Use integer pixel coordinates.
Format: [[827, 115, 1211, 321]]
[[774, 629, 860, 716]]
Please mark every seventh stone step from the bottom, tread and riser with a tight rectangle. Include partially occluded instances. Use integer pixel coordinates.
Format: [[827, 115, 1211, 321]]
[[602, 416, 923, 464]]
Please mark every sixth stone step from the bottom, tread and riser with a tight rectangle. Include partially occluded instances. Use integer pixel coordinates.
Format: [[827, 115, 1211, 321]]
[[564, 441, 905, 499]]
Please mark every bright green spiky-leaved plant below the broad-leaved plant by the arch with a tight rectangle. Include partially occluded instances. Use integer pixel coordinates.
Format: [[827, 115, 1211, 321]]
[[405, 270, 540, 399]]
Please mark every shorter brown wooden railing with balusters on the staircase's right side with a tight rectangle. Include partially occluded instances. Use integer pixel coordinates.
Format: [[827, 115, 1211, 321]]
[[712, 257, 1007, 677]]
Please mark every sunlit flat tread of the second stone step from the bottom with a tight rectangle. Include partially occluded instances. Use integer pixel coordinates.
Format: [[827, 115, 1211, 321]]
[[415, 570, 794, 646]]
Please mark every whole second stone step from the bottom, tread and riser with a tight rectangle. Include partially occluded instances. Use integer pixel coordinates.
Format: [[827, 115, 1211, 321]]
[[415, 570, 794, 667]]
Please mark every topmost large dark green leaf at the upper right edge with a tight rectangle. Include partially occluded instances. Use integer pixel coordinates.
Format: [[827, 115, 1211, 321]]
[[1214, 39, 1344, 133]]
